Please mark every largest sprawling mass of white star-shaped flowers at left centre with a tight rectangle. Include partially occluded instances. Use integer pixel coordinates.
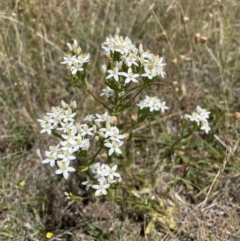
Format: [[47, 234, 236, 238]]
[[38, 101, 125, 183]]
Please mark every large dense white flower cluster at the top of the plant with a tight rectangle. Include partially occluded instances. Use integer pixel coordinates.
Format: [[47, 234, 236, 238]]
[[102, 35, 165, 90]]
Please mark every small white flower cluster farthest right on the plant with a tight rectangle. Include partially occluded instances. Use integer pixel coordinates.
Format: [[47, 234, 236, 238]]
[[184, 106, 211, 134]]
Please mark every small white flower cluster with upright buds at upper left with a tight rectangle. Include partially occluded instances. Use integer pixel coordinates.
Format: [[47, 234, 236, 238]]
[[61, 40, 90, 75]]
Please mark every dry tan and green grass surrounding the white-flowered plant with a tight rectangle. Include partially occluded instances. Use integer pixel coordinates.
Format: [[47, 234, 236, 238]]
[[0, 0, 240, 241]]
